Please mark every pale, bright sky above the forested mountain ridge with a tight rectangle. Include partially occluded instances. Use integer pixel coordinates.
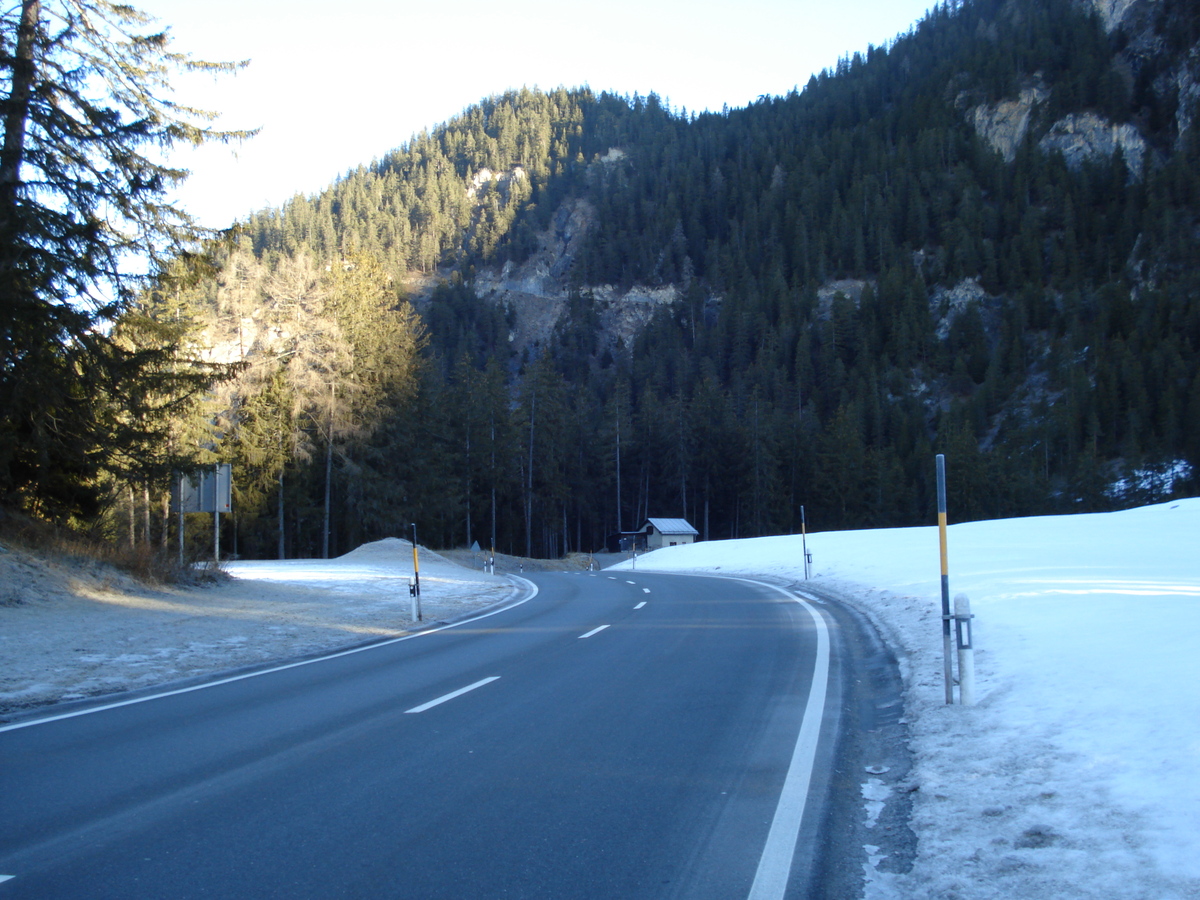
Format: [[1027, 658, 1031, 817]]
[[134, 0, 929, 227]]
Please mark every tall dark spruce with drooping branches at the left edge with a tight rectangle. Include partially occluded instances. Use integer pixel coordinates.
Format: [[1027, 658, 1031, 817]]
[[0, 0, 247, 516]]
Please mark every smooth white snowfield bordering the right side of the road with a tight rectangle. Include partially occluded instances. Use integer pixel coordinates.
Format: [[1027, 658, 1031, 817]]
[[623, 499, 1200, 900]]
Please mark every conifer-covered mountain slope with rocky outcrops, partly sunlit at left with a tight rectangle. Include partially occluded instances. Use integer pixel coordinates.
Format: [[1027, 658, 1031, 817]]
[[150, 0, 1200, 554]]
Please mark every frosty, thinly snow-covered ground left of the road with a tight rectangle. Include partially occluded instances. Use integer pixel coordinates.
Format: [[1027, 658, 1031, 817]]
[[0, 539, 518, 712]]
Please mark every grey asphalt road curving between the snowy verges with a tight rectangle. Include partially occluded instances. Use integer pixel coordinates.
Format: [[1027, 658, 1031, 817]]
[[0, 572, 902, 900]]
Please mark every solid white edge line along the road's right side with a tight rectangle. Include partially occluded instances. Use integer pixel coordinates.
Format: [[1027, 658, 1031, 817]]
[[749, 582, 829, 900]]
